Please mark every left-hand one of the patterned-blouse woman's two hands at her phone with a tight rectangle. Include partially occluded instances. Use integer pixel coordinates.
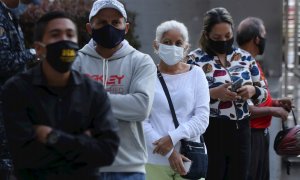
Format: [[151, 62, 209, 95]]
[[212, 83, 240, 102]]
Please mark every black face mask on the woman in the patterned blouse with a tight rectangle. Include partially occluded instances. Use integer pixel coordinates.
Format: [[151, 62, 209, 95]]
[[207, 38, 234, 54]]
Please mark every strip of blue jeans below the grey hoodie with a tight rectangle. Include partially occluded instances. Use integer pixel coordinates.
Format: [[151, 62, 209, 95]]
[[99, 172, 146, 180]]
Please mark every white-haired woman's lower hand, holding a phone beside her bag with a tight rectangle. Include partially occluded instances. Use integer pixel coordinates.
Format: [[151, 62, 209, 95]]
[[168, 150, 191, 175]]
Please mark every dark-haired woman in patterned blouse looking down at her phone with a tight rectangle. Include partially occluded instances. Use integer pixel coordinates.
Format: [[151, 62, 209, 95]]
[[188, 8, 267, 180]]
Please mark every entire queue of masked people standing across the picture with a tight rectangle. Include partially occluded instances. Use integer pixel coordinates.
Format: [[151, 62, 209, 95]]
[[0, 0, 292, 180]]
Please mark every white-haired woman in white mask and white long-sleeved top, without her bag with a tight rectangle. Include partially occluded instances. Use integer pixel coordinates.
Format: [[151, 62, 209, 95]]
[[144, 20, 210, 180]]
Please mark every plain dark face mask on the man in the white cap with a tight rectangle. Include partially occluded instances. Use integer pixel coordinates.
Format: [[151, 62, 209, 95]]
[[92, 24, 125, 49]]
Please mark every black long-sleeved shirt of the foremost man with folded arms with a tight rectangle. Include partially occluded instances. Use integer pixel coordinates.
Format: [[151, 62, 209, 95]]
[[3, 65, 119, 179]]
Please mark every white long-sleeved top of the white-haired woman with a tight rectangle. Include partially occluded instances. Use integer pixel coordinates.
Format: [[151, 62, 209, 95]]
[[143, 66, 210, 165]]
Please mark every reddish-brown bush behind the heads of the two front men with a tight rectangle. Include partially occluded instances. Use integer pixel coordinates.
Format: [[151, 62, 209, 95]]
[[20, 0, 140, 49]]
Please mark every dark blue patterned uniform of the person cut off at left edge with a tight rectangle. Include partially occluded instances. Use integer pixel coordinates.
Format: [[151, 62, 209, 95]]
[[0, 1, 34, 172]]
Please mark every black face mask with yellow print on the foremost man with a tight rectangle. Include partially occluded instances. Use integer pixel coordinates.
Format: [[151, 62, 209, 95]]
[[46, 40, 79, 73]]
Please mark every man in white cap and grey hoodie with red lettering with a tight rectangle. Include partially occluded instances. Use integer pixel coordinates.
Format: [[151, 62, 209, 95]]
[[73, 0, 156, 180]]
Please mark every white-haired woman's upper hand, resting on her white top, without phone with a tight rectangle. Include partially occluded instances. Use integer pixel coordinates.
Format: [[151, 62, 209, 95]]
[[152, 135, 174, 156]]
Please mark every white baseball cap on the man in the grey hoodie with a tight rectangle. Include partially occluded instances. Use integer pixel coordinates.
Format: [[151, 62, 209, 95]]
[[89, 0, 127, 21]]
